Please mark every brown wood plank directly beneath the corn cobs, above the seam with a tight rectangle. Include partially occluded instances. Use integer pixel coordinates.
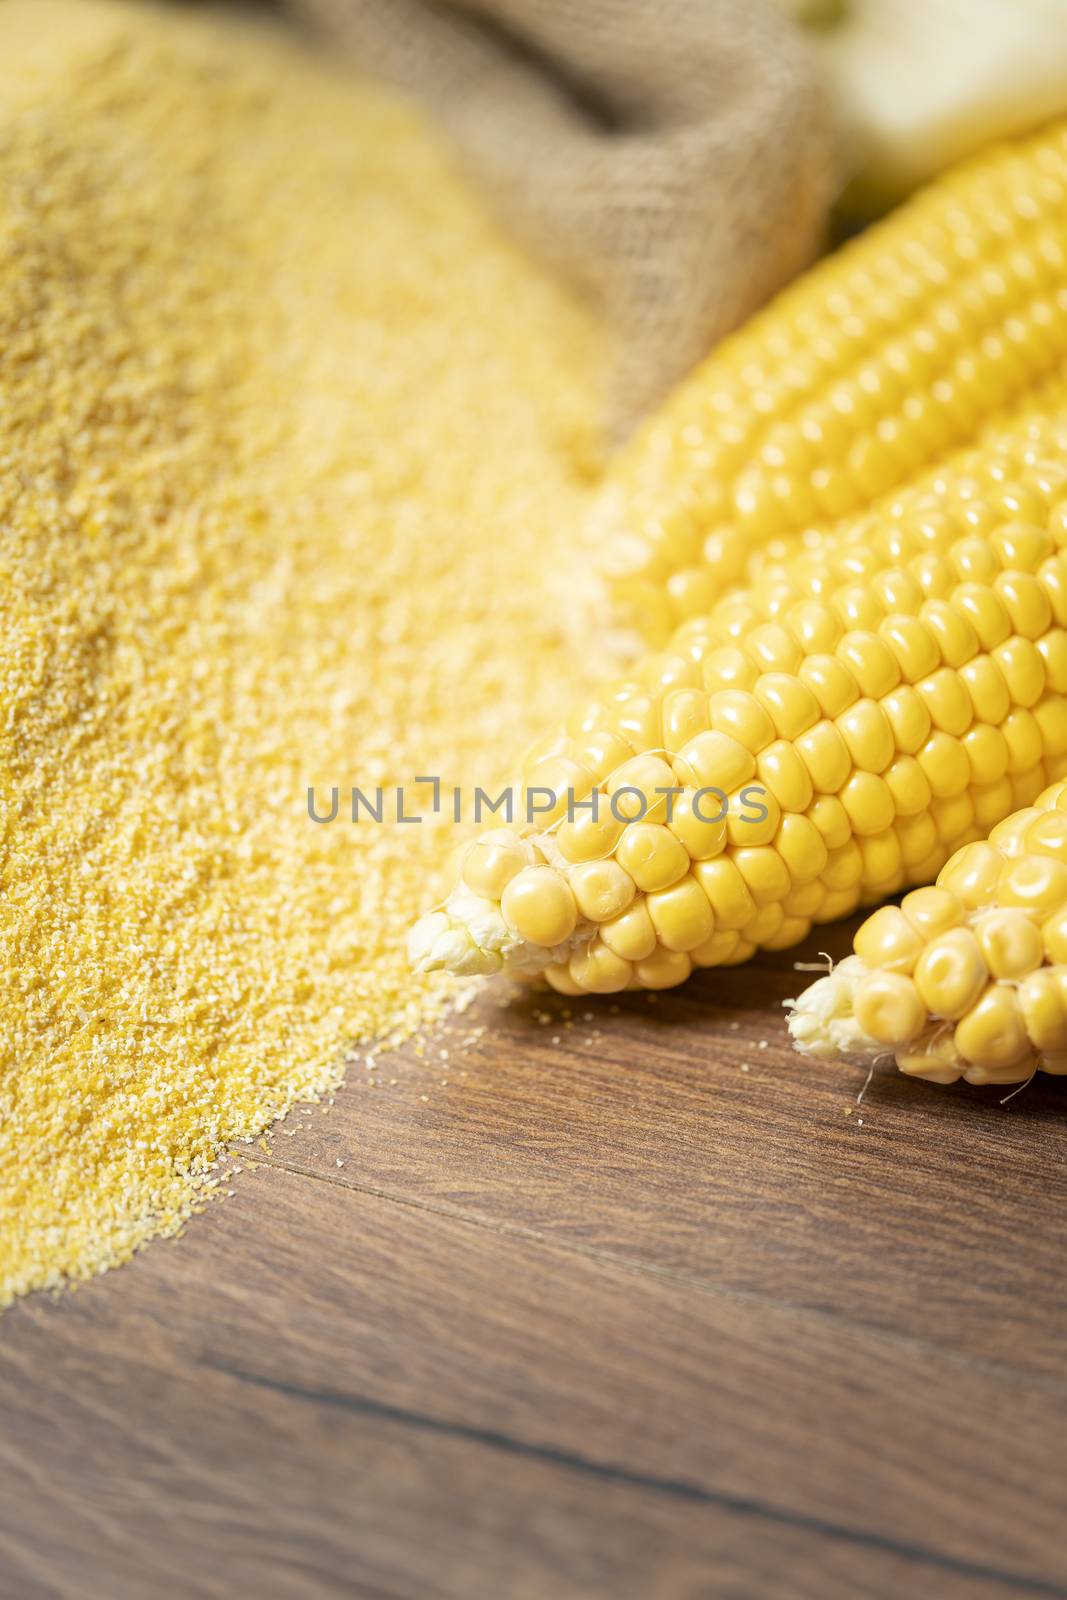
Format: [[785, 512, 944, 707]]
[[255, 925, 1067, 1378]]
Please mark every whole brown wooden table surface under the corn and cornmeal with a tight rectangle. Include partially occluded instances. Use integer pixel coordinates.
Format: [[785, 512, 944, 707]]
[[0, 928, 1067, 1600]]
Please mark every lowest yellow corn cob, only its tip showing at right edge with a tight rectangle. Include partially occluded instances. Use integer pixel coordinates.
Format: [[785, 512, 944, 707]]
[[789, 782, 1067, 1083]]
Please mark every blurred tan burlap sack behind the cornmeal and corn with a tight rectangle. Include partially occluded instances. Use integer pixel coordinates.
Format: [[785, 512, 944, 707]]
[[290, 0, 833, 435]]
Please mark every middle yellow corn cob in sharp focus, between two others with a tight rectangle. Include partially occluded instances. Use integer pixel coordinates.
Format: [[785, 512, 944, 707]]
[[411, 414, 1067, 994]]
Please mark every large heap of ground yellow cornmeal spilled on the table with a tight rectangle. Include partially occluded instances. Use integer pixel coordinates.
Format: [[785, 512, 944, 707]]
[[0, 0, 600, 1301]]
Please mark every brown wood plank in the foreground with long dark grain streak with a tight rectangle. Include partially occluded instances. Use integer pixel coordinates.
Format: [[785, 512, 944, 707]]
[[0, 1168, 1067, 1600]]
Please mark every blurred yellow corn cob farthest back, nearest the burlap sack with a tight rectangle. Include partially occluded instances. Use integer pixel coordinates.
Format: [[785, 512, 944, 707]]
[[593, 123, 1067, 645]]
